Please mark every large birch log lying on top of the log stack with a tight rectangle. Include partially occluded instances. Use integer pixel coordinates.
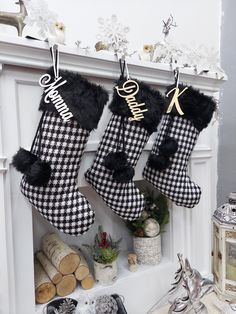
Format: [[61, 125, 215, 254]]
[[42, 233, 80, 275]]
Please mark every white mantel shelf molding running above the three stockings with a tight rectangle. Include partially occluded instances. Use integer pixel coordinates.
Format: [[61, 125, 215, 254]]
[[0, 36, 227, 92]]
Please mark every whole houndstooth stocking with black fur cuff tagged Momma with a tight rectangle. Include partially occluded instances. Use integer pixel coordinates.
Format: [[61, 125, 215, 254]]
[[13, 69, 108, 236]]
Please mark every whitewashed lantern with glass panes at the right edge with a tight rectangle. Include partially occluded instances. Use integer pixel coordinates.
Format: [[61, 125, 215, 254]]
[[213, 192, 236, 301]]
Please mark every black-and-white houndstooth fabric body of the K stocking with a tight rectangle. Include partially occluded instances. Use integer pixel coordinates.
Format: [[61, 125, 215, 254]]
[[143, 115, 201, 208]]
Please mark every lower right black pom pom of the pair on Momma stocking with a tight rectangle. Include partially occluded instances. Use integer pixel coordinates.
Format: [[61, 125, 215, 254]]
[[25, 160, 51, 186]]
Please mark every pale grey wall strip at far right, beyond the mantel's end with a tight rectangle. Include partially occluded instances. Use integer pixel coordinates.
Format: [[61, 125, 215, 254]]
[[217, 0, 236, 206]]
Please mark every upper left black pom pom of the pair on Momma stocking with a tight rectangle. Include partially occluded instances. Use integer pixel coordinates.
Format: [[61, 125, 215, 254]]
[[12, 148, 38, 173]]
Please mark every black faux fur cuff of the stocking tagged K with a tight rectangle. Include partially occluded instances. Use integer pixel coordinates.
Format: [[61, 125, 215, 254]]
[[166, 84, 216, 131]]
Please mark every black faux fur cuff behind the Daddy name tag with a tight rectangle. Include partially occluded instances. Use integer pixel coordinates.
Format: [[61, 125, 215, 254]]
[[109, 79, 165, 134]]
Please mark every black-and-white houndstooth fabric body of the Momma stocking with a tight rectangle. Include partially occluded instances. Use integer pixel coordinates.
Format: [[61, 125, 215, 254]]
[[21, 111, 94, 236]]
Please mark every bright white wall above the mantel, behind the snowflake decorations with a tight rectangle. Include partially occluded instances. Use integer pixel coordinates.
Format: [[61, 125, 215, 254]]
[[0, 0, 221, 51]]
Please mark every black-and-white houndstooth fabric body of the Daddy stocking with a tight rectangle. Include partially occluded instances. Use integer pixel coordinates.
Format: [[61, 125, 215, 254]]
[[85, 115, 149, 220]]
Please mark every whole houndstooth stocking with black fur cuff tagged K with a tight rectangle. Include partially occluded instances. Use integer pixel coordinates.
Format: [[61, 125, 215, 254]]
[[143, 85, 216, 208]]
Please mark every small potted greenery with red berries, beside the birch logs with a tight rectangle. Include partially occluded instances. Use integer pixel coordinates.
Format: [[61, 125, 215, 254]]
[[84, 226, 121, 285]]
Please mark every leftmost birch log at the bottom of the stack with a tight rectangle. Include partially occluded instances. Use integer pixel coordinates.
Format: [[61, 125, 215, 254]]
[[34, 259, 56, 304]]
